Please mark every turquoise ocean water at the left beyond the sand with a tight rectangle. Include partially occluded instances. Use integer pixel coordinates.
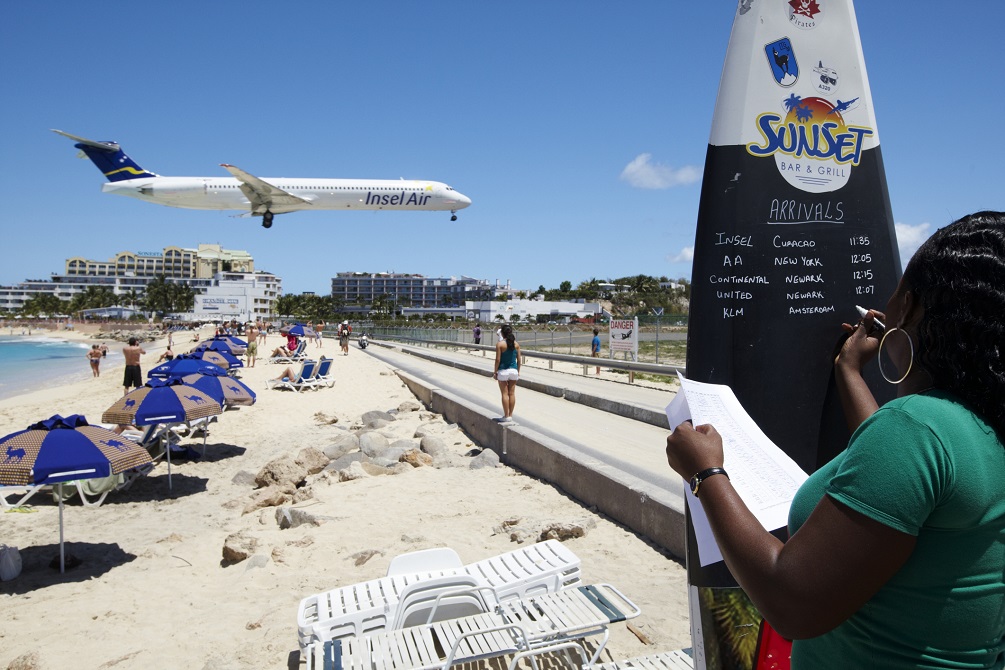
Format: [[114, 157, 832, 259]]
[[0, 336, 103, 400]]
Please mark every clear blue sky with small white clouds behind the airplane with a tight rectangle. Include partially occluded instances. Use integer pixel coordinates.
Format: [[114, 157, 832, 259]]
[[0, 0, 1005, 293]]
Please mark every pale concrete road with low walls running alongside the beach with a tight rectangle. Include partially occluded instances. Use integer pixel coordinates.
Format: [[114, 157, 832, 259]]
[[363, 343, 684, 557]]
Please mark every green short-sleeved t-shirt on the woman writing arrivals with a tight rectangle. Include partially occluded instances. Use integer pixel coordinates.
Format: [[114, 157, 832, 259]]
[[789, 391, 1005, 670]]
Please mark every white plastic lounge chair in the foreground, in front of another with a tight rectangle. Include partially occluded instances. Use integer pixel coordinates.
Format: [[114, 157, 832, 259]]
[[308, 584, 641, 670]]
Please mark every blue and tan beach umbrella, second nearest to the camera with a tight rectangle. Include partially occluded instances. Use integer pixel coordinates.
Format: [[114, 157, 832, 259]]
[[102, 378, 223, 488]]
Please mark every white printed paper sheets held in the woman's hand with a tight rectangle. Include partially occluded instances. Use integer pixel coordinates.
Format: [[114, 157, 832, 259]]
[[666, 376, 808, 566]]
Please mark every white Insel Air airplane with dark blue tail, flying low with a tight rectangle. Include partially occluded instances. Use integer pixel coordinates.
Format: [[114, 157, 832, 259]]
[[52, 129, 471, 228]]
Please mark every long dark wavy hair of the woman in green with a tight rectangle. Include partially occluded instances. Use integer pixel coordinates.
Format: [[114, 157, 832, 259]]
[[903, 212, 1005, 438]]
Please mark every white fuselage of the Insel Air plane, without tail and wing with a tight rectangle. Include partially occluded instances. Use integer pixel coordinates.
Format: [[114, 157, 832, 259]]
[[102, 177, 471, 214]]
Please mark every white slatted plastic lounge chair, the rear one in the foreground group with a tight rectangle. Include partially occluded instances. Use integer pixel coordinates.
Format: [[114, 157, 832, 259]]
[[296, 539, 581, 649]]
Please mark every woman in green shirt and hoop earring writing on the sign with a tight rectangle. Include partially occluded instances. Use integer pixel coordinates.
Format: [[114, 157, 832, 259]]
[[666, 212, 1005, 669]]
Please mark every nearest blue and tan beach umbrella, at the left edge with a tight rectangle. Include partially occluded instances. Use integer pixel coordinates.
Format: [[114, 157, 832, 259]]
[[0, 414, 151, 573]]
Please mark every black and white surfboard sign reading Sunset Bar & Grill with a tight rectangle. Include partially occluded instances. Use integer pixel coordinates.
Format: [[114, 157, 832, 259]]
[[687, 0, 900, 668]]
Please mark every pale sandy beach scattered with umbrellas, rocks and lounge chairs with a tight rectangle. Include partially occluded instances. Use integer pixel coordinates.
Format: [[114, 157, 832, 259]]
[[0, 332, 690, 669]]
